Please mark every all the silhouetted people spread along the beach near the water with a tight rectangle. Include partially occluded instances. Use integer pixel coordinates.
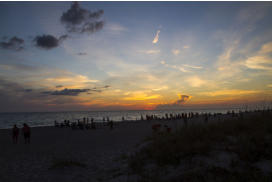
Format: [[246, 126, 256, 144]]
[[12, 109, 272, 144]]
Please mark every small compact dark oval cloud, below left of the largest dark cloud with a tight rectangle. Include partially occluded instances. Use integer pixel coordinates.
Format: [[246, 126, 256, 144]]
[[34, 35, 68, 49]]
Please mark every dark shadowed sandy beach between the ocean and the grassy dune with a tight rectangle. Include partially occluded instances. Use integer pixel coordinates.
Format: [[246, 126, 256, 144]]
[[0, 113, 270, 182]]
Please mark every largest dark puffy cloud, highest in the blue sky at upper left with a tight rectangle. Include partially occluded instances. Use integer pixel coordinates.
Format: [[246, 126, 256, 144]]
[[61, 2, 104, 33]]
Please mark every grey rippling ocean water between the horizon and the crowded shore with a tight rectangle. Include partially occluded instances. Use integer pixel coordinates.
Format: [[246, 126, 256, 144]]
[[0, 108, 242, 129]]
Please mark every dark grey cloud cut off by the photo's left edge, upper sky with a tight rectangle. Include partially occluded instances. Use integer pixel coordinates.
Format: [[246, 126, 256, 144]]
[[0, 36, 24, 51]]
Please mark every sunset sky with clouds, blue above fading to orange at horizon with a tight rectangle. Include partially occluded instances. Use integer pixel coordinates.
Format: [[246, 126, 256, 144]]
[[0, 1, 272, 112]]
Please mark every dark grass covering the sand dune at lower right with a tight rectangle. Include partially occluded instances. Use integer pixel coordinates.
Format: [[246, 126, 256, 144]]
[[128, 111, 272, 182]]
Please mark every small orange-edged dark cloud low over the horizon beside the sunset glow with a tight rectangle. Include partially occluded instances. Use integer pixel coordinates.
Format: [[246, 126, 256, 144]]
[[156, 94, 192, 110]]
